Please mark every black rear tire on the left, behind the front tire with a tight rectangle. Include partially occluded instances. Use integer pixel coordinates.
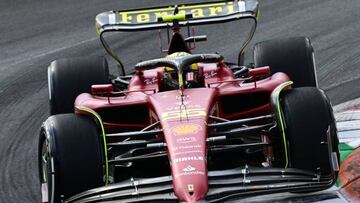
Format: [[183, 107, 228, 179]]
[[48, 56, 110, 115]]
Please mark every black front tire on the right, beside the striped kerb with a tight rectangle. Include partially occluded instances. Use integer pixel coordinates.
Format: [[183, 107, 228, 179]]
[[280, 87, 339, 180]]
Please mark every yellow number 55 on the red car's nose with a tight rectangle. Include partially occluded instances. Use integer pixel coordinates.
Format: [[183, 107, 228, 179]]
[[161, 108, 207, 121]]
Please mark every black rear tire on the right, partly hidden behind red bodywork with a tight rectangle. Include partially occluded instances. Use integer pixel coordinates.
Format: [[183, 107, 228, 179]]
[[254, 37, 317, 87]]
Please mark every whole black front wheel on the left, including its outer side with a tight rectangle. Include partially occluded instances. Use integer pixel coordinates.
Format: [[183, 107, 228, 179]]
[[38, 114, 104, 203]]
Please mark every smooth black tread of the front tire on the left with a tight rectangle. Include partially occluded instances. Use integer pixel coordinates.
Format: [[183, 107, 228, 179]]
[[42, 114, 104, 202]]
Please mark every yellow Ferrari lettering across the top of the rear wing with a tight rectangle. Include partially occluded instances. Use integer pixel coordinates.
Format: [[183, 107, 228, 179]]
[[118, 1, 245, 24]]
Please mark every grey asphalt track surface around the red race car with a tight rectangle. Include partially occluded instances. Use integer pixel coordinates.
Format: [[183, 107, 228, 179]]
[[0, 0, 360, 202]]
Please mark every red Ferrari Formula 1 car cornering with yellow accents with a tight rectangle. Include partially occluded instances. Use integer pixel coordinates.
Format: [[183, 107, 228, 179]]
[[39, 0, 339, 202]]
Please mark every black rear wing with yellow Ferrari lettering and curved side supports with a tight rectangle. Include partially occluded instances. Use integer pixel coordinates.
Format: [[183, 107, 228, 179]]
[[96, 0, 259, 75]]
